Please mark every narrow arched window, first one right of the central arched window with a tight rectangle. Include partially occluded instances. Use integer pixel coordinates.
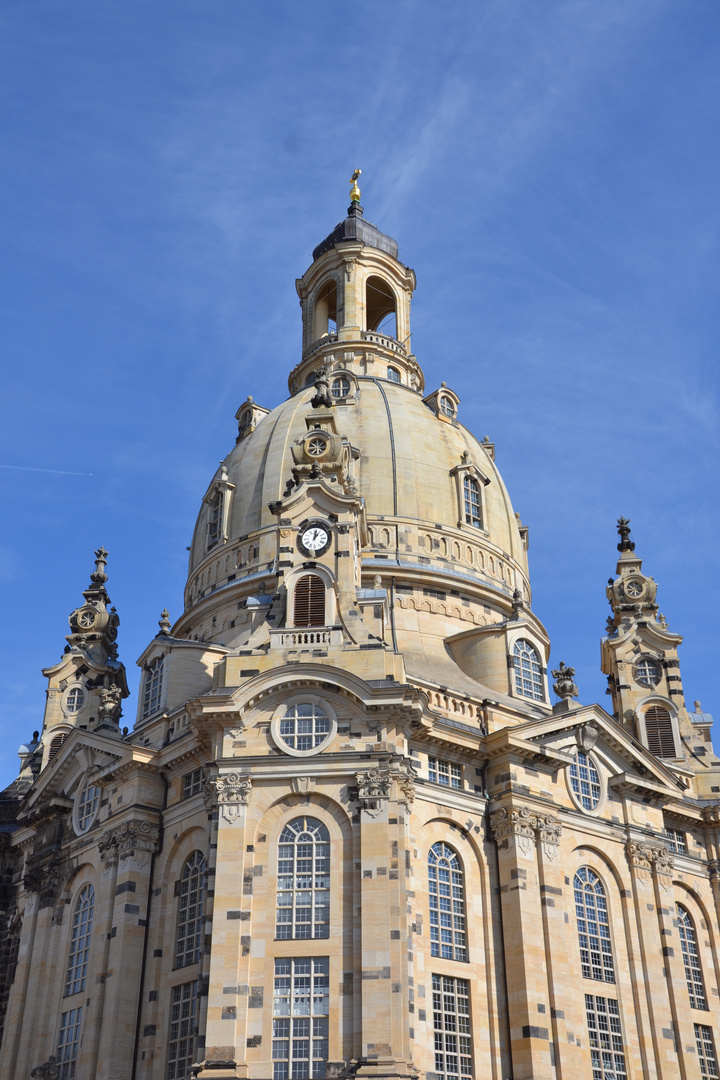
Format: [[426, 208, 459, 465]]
[[427, 840, 467, 960]]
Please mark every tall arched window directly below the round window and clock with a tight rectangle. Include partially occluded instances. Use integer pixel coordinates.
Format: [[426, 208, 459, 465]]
[[275, 818, 330, 939]]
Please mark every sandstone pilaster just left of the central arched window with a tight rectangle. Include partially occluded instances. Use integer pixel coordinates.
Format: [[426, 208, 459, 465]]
[[198, 771, 252, 1080]]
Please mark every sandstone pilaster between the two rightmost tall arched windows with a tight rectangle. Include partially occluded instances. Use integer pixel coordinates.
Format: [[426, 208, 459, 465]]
[[625, 839, 680, 1080]]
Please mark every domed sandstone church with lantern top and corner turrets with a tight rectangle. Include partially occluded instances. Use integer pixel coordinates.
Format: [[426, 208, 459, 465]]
[[0, 184, 720, 1080]]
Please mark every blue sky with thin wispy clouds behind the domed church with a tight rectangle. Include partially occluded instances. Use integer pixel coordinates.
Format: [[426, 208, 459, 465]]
[[0, 0, 720, 781]]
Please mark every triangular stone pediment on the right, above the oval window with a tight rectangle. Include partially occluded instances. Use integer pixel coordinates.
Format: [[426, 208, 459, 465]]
[[498, 705, 683, 801]]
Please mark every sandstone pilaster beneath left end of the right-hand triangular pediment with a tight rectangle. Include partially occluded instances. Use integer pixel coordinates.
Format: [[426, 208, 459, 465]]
[[490, 800, 554, 1080]]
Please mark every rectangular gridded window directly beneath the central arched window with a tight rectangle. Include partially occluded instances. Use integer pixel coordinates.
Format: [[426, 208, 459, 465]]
[[272, 956, 330, 1080]]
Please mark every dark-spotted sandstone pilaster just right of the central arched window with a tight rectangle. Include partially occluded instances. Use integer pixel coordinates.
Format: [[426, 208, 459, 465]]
[[355, 762, 418, 1078]]
